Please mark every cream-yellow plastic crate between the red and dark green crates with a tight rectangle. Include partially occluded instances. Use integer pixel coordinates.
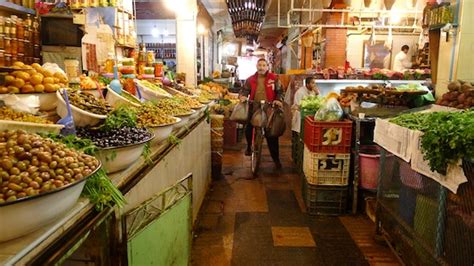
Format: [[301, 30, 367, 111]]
[[303, 145, 351, 186]]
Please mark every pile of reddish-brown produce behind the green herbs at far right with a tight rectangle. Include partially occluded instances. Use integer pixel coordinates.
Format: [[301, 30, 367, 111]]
[[436, 80, 474, 109]]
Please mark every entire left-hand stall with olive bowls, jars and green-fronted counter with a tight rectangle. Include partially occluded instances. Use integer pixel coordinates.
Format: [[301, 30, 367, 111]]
[[0, 1, 218, 265]]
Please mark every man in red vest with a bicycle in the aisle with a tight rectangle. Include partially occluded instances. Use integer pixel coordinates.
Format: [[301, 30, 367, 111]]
[[240, 58, 283, 168]]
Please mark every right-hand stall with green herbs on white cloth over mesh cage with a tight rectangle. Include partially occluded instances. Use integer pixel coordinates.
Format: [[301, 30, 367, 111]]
[[374, 106, 474, 265]]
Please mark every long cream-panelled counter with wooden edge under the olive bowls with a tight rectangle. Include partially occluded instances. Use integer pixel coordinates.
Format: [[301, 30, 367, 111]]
[[0, 112, 211, 265]]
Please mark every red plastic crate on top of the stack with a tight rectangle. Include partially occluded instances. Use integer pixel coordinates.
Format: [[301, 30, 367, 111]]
[[304, 116, 352, 153]]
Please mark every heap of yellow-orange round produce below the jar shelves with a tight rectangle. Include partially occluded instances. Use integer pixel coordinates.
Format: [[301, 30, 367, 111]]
[[0, 62, 68, 94]]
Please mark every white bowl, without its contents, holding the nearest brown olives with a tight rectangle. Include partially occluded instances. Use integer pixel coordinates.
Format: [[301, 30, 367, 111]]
[[0, 165, 101, 242]]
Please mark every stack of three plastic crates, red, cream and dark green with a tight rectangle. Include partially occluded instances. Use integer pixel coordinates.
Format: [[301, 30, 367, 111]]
[[302, 116, 352, 215]]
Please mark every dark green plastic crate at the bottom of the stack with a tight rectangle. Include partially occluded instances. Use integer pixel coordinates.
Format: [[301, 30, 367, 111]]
[[303, 178, 349, 215]]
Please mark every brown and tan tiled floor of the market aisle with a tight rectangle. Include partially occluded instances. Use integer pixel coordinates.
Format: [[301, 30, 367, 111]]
[[192, 132, 398, 265]]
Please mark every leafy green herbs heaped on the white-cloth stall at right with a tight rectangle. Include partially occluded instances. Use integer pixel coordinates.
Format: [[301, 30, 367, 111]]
[[390, 110, 474, 174]]
